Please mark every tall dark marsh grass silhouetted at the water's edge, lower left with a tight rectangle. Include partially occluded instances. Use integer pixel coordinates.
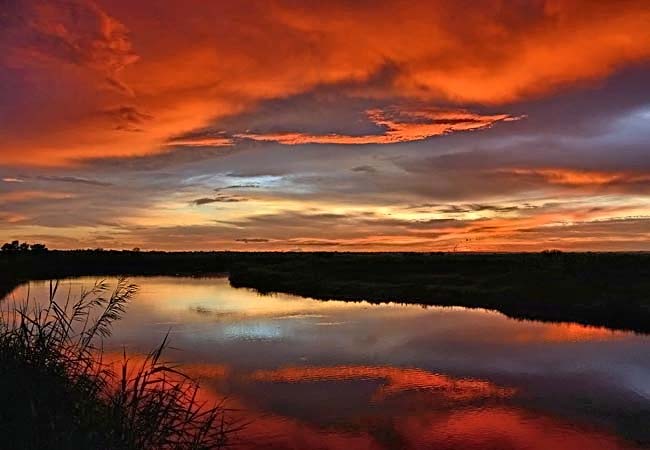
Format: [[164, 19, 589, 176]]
[[0, 279, 238, 449]]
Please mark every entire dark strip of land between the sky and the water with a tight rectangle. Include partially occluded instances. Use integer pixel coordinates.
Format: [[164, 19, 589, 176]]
[[0, 250, 650, 332]]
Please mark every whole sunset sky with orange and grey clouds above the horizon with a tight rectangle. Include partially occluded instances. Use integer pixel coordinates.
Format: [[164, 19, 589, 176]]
[[0, 0, 650, 251]]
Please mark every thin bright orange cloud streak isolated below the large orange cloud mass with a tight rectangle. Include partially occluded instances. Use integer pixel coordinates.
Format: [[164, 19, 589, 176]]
[[235, 108, 520, 145]]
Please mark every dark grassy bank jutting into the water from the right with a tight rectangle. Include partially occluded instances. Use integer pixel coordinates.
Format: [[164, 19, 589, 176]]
[[230, 251, 650, 332]]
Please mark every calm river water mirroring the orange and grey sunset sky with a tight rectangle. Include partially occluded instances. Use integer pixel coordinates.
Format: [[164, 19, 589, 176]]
[[5, 277, 650, 450]]
